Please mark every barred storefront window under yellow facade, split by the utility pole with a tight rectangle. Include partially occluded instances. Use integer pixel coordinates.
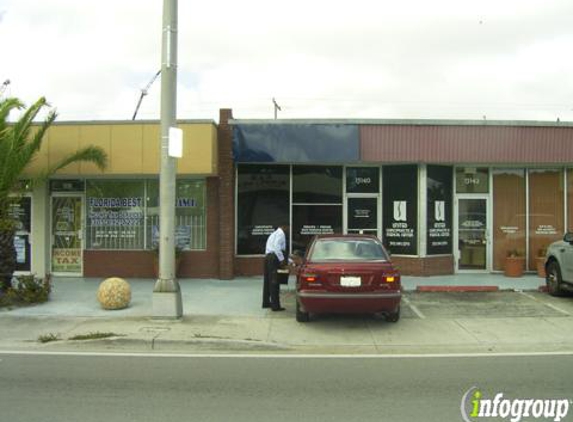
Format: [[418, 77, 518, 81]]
[[146, 179, 207, 251]]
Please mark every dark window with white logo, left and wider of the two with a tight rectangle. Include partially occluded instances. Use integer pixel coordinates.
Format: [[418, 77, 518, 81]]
[[383, 165, 418, 255]]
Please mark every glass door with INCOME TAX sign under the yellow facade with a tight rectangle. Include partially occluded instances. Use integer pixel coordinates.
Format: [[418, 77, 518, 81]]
[[51, 196, 83, 275]]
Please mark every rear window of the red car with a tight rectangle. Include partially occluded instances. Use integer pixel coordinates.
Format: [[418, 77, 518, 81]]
[[309, 239, 388, 261]]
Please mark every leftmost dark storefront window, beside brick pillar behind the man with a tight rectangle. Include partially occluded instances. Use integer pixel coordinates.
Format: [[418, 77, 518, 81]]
[[237, 165, 290, 255]]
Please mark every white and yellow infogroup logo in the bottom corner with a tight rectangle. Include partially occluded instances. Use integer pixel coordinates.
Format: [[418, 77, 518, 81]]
[[460, 386, 571, 422]]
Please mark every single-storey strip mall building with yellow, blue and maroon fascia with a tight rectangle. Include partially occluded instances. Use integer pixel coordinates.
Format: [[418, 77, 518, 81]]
[[14, 109, 573, 279]]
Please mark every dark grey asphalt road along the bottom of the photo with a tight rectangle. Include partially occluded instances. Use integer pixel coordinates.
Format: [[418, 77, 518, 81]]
[[0, 354, 573, 422]]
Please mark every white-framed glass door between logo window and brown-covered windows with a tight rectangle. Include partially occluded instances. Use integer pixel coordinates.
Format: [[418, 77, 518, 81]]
[[457, 197, 489, 271]]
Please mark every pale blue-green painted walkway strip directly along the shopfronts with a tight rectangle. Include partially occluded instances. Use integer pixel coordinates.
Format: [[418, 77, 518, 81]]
[[0, 274, 545, 317]]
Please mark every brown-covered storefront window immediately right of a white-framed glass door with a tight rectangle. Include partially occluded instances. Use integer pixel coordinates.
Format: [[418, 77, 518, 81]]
[[493, 169, 526, 271]]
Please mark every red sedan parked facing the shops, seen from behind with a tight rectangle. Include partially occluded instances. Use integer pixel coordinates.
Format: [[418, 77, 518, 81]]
[[296, 235, 402, 322]]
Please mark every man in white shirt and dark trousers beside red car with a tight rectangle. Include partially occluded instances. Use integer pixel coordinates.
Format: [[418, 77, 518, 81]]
[[263, 225, 289, 312]]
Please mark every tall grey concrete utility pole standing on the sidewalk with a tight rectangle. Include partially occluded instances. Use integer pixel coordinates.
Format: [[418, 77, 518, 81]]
[[153, 0, 183, 319]]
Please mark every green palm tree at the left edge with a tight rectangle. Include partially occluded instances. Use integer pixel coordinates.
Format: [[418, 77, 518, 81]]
[[0, 97, 107, 290]]
